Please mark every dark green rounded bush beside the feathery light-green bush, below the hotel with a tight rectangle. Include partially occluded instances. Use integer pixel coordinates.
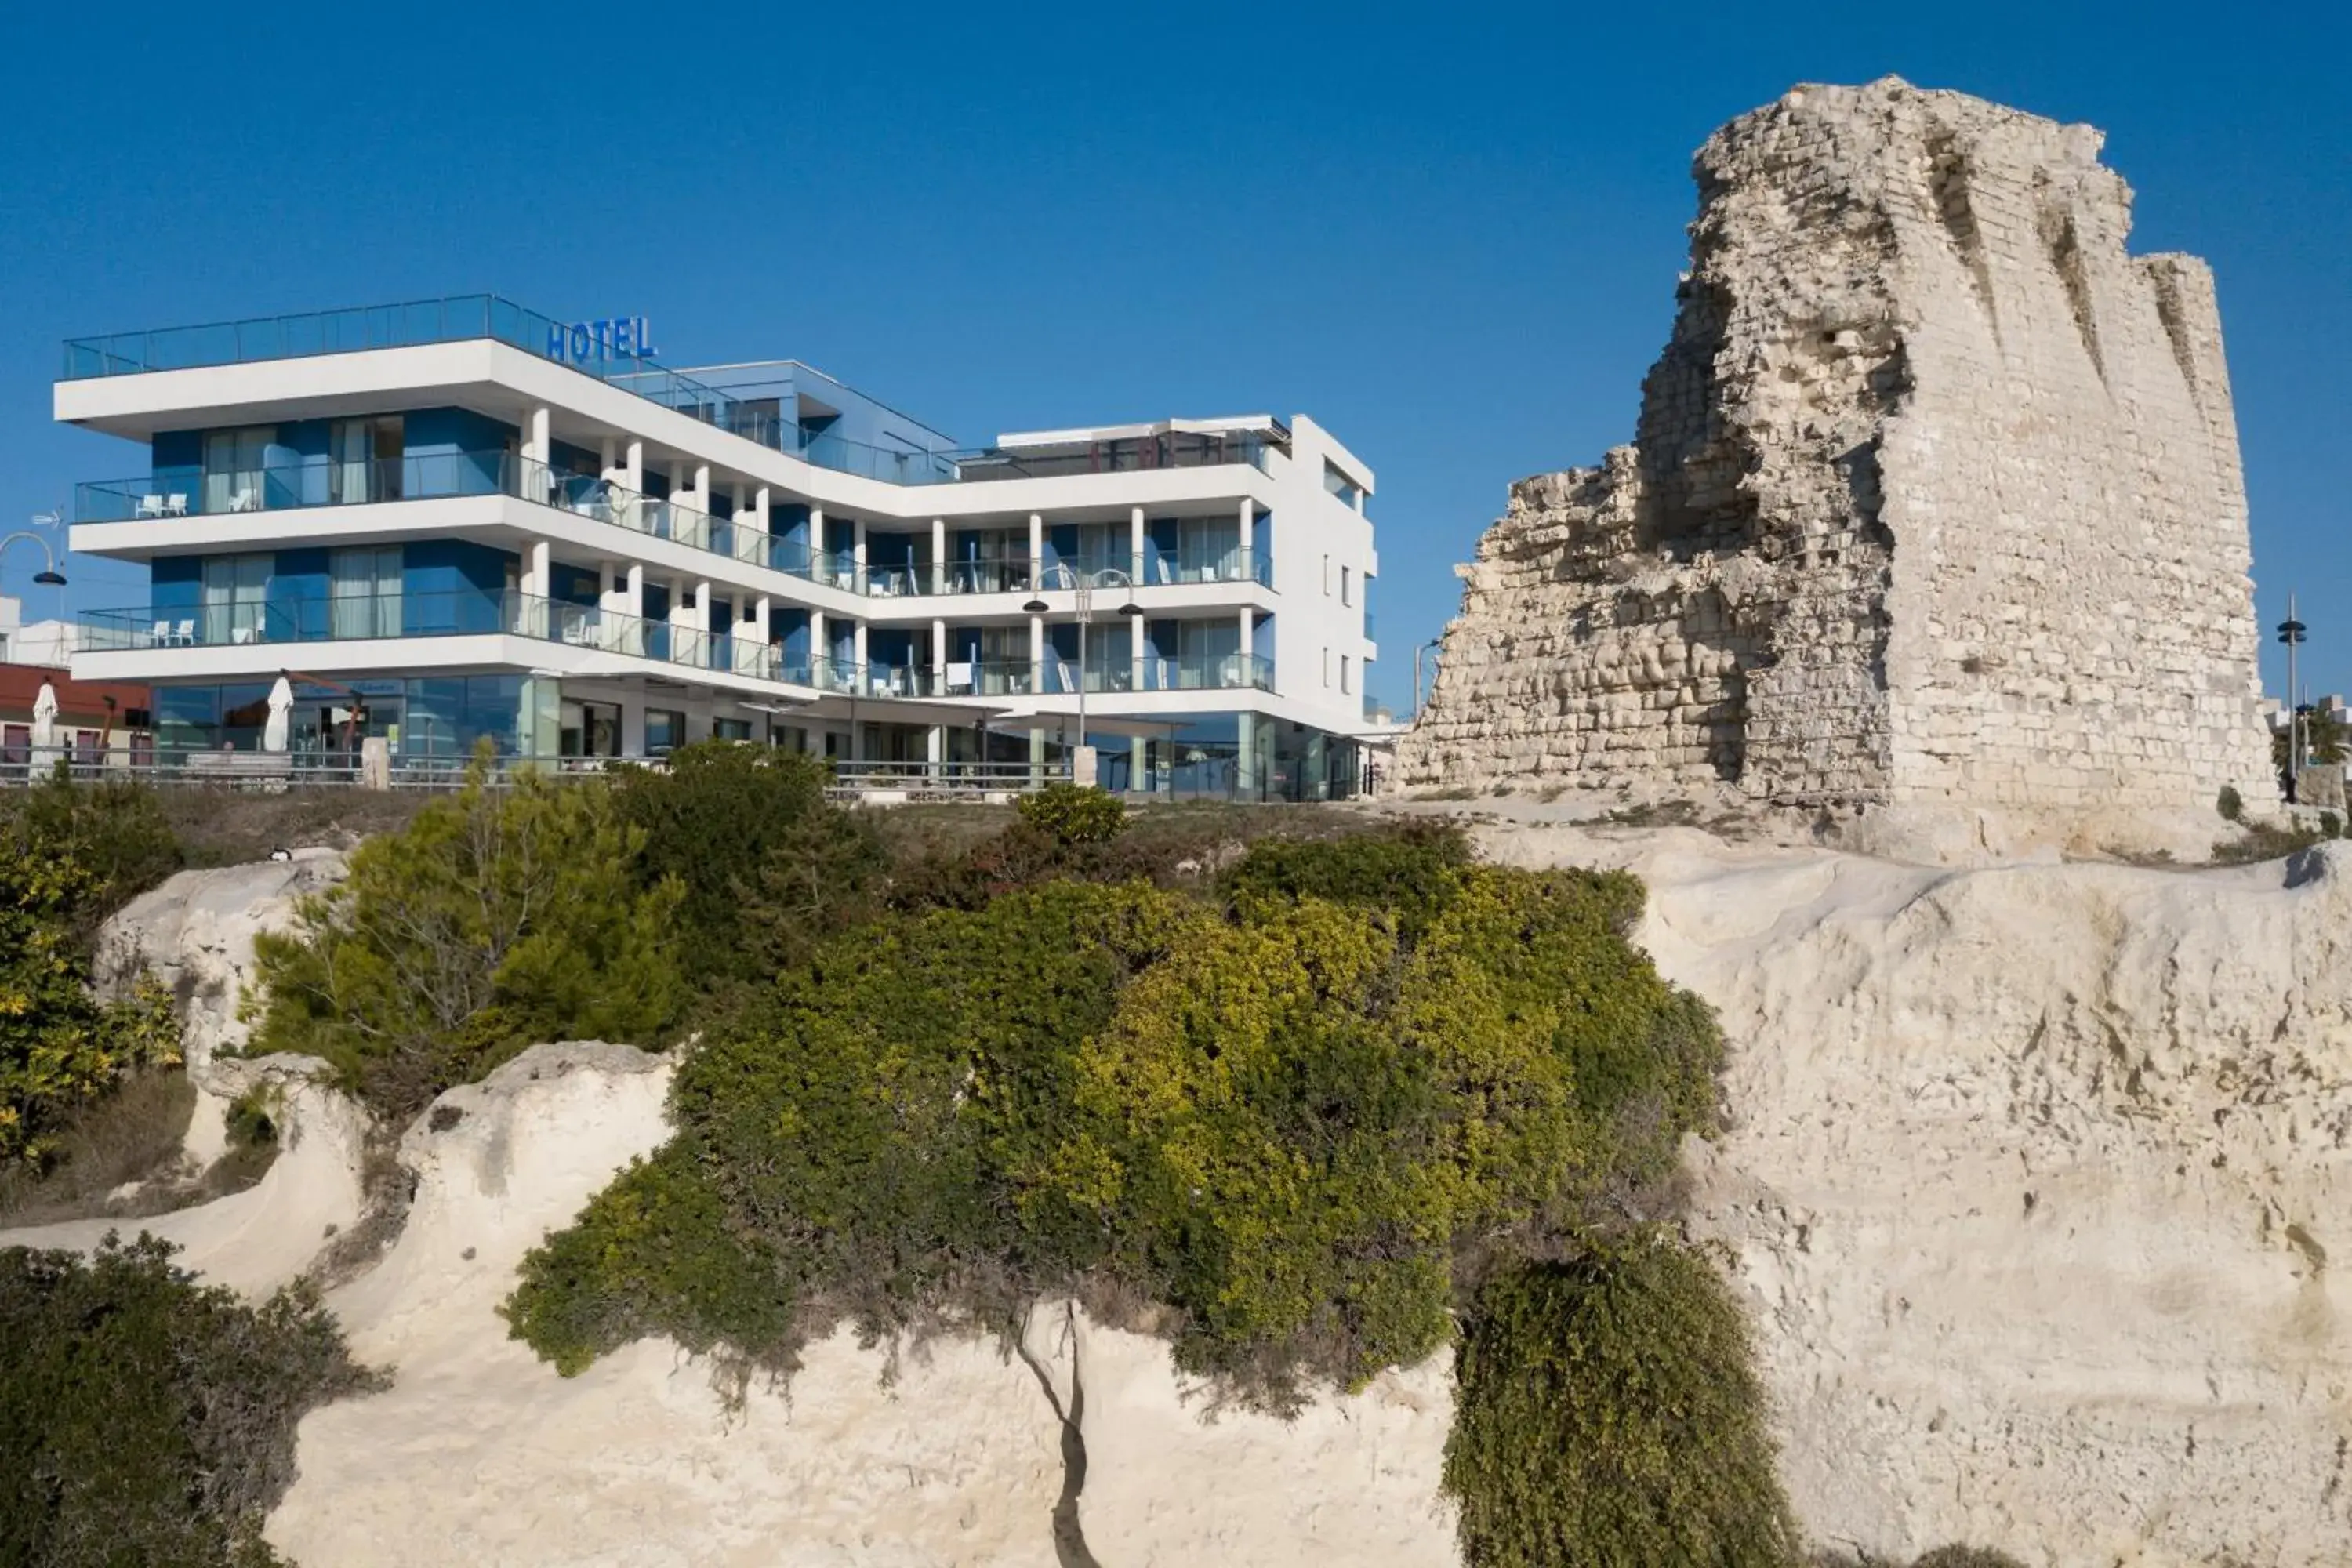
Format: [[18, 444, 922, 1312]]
[[614, 741, 889, 980]]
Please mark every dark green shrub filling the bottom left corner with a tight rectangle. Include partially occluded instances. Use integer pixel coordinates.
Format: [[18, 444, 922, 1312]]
[[0, 1236, 379, 1568]]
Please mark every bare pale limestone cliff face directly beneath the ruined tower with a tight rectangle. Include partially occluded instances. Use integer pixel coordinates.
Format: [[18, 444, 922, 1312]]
[[1479, 827, 2352, 1568]]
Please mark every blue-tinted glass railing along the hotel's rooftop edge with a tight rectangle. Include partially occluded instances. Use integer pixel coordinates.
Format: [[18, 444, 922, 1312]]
[[61, 294, 1270, 485]]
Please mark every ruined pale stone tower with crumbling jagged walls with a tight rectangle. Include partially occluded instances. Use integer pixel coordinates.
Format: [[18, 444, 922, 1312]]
[[1399, 78, 2277, 813]]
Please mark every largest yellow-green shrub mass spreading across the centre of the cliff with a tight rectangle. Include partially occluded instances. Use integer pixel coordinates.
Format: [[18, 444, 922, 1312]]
[[508, 837, 1719, 1406]]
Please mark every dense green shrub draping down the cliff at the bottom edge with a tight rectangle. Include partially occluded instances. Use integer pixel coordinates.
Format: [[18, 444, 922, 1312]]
[[1444, 1234, 1797, 1568]]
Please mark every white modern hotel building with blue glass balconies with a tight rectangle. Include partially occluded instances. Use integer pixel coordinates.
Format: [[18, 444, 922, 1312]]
[[56, 296, 1378, 799]]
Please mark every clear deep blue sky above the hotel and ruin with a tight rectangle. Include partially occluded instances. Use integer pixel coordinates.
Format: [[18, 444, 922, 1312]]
[[0, 0, 2352, 706]]
